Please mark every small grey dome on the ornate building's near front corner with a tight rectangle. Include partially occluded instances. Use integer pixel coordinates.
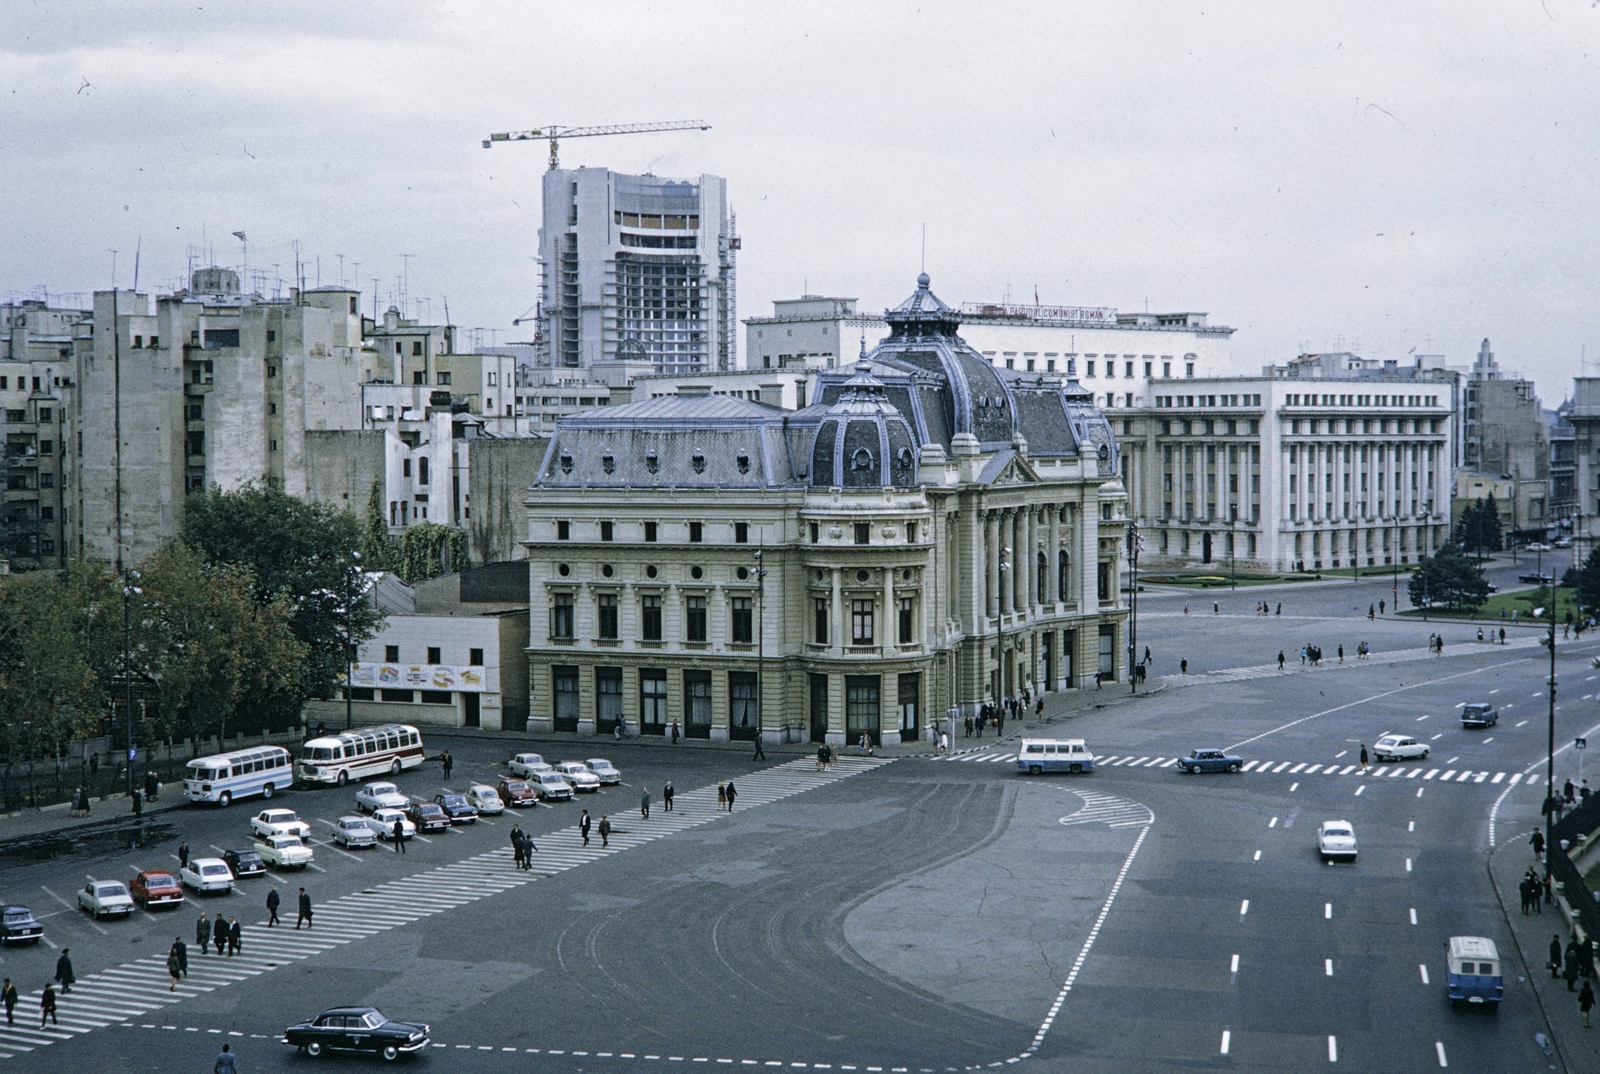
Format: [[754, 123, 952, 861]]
[[811, 363, 917, 488]]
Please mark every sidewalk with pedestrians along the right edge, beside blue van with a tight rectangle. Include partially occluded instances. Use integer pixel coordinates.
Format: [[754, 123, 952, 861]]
[[1488, 832, 1600, 1071]]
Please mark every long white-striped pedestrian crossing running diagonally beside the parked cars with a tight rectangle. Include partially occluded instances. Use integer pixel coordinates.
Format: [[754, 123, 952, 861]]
[[0, 757, 893, 1060]]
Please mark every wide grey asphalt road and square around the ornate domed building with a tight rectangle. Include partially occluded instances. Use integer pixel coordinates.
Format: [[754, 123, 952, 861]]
[[0, 560, 1600, 1074]]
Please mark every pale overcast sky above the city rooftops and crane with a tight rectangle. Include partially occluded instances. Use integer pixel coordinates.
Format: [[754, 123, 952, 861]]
[[0, 0, 1600, 407]]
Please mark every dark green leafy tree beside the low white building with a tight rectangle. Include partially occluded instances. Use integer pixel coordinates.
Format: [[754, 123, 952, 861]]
[[182, 485, 382, 727]]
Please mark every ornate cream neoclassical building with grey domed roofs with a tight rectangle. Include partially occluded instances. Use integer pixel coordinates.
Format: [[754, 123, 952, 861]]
[[525, 275, 1126, 743]]
